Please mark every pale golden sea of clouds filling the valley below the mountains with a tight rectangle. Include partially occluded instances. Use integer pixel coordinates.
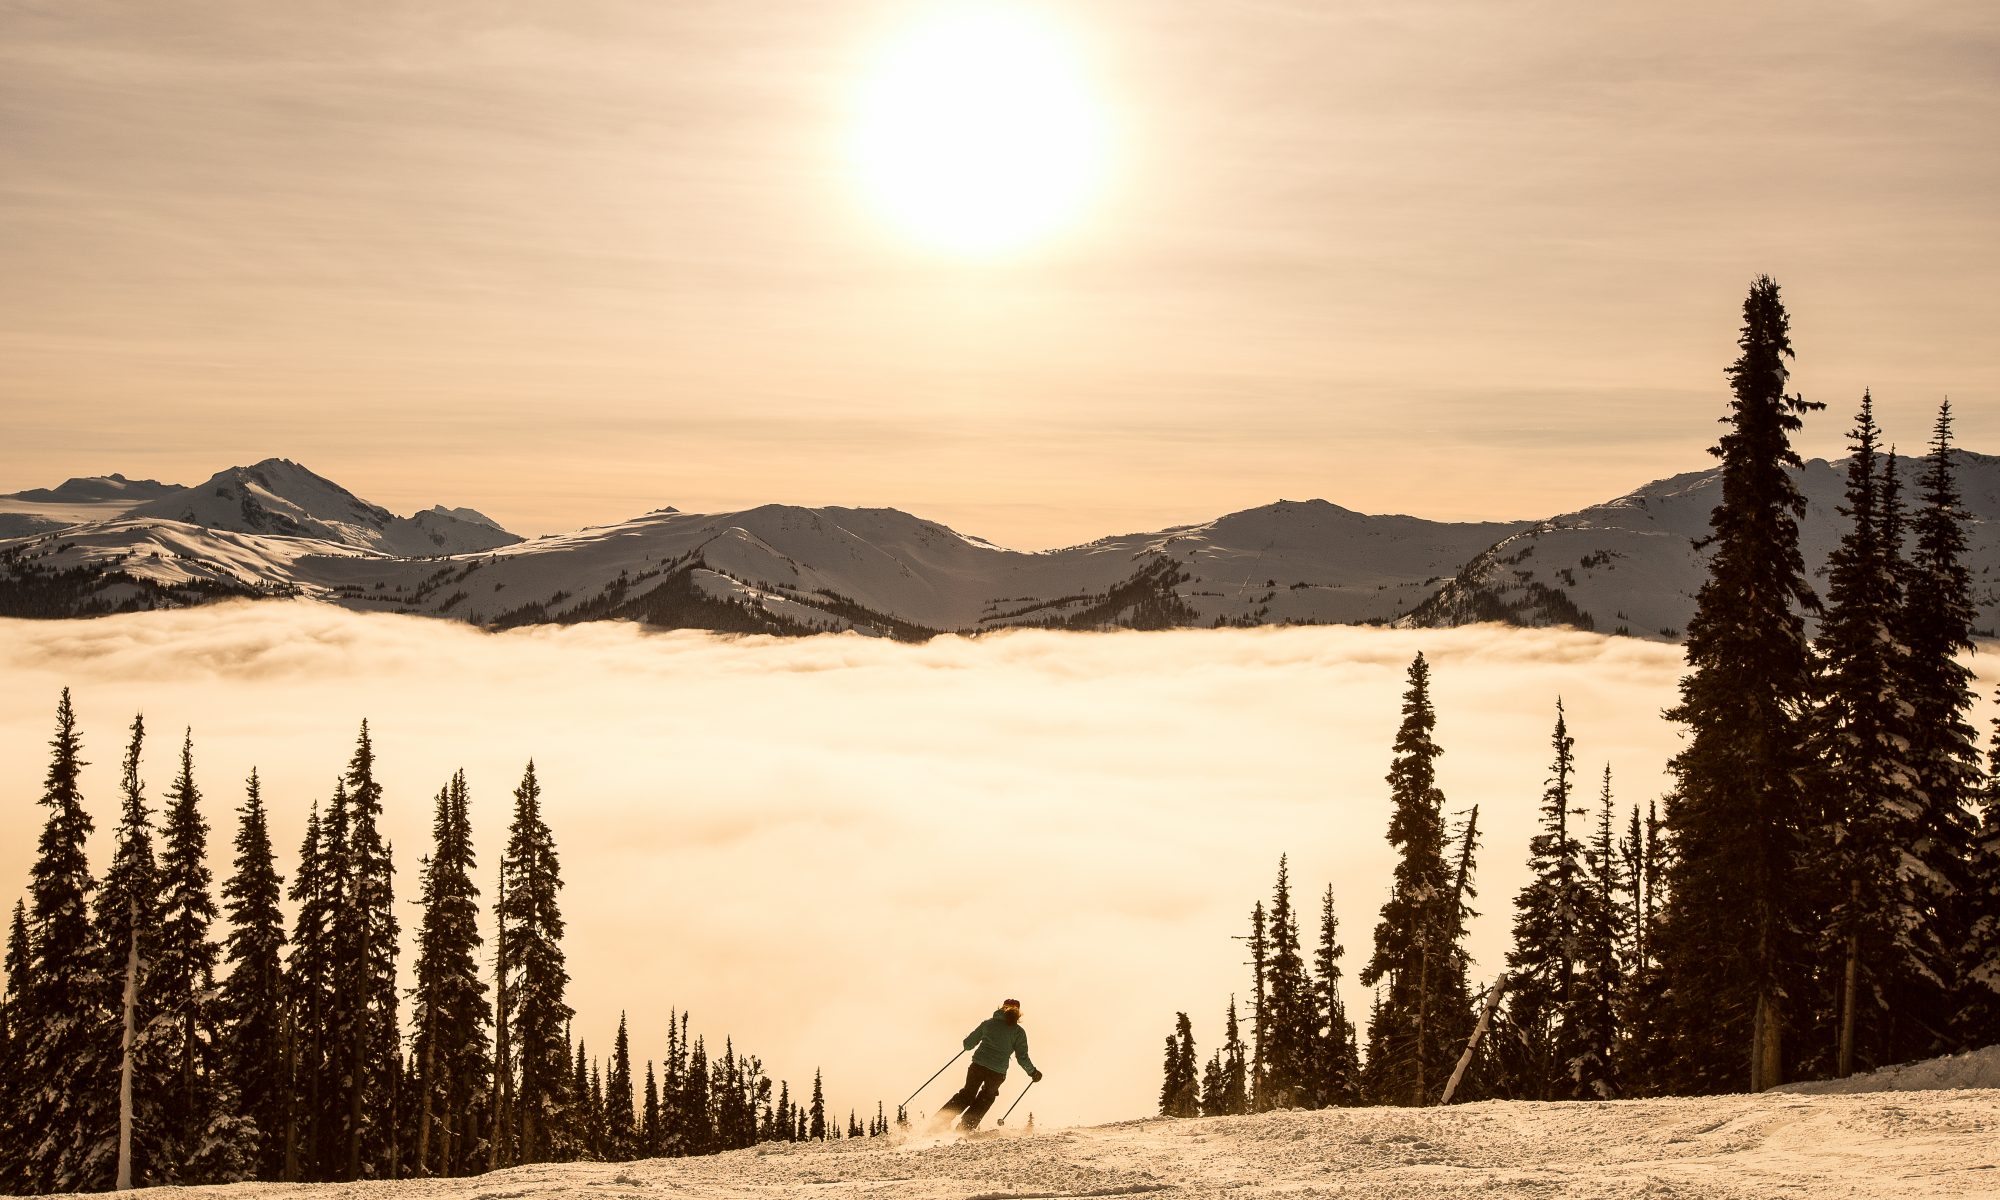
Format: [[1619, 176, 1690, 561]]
[[0, 602, 1990, 1124]]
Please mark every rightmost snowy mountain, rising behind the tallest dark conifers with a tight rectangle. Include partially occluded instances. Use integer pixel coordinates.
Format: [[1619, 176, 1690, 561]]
[[1404, 450, 2000, 640]]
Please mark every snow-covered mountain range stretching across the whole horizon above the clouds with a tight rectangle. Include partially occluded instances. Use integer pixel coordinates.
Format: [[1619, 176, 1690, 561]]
[[0, 452, 2000, 640]]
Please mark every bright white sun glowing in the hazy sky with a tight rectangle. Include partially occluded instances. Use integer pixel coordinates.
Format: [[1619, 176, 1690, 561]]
[[852, 4, 1108, 258]]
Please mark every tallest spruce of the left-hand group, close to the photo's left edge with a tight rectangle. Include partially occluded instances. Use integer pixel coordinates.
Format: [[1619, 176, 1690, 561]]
[[12, 688, 102, 1192]]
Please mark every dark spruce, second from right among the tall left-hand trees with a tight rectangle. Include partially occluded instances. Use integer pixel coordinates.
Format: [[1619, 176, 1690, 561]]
[[410, 770, 492, 1176]]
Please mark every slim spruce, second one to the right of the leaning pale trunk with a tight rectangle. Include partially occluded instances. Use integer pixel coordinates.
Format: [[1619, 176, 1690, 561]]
[[1564, 764, 1628, 1100]]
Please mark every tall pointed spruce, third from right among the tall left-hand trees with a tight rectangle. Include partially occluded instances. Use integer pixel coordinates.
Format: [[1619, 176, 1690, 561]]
[[328, 720, 402, 1180]]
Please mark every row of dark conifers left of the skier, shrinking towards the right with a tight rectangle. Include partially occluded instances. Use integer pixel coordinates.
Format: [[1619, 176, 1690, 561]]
[[0, 712, 890, 1194]]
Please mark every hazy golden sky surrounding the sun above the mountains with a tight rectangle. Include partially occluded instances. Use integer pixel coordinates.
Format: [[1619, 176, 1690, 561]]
[[0, 0, 2000, 548]]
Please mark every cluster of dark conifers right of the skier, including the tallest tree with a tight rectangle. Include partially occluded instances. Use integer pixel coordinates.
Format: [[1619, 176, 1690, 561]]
[[1160, 278, 2000, 1116]]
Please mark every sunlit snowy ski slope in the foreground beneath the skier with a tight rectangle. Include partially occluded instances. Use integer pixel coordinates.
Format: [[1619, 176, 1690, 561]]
[[121, 1090, 2000, 1200]]
